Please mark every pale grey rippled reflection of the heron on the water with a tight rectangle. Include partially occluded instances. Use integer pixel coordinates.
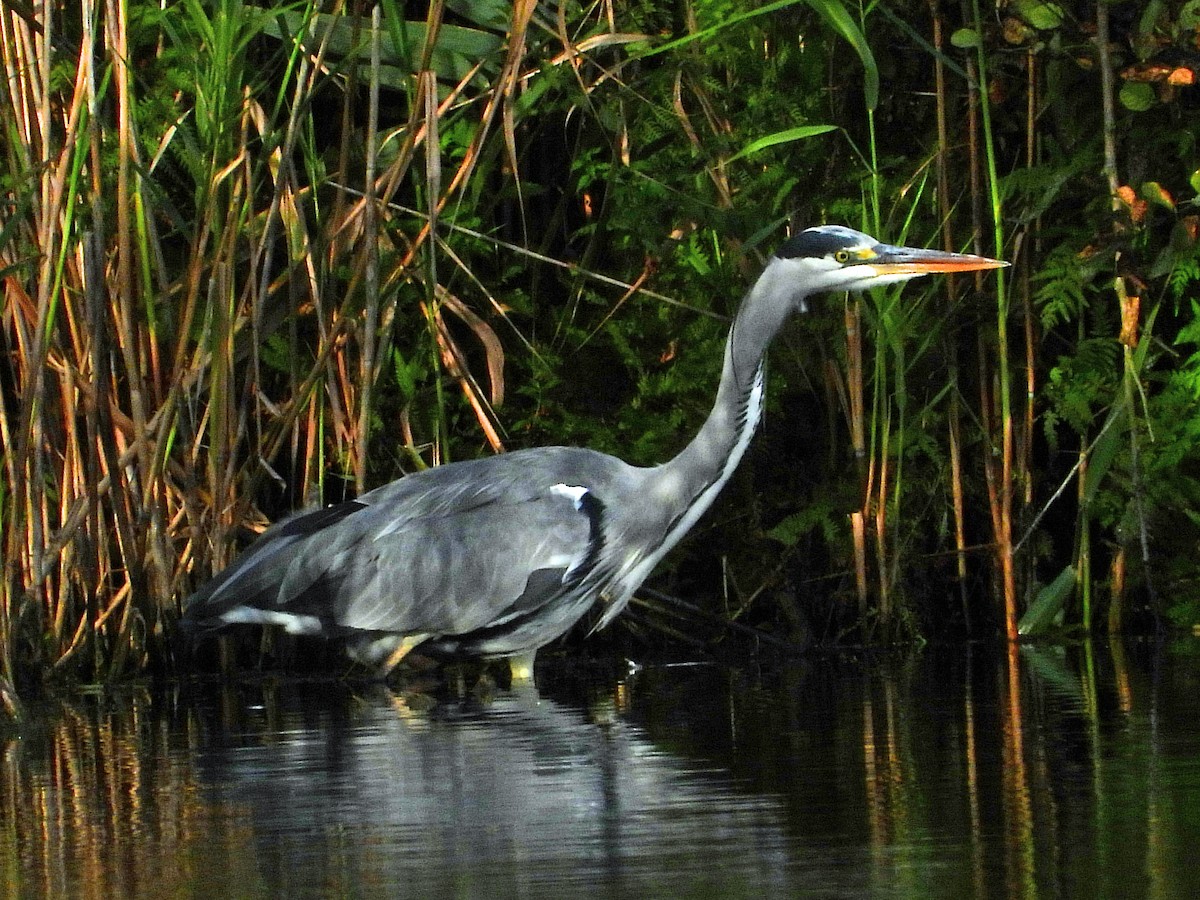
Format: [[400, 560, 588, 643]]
[[197, 690, 793, 896]]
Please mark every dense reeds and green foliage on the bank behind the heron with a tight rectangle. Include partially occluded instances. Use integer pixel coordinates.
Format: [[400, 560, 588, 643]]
[[0, 0, 1200, 709]]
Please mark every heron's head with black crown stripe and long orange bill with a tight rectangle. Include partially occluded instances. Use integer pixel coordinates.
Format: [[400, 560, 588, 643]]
[[772, 226, 1008, 308]]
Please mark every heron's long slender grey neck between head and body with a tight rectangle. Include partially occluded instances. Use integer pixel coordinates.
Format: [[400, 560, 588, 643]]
[[658, 265, 797, 542]]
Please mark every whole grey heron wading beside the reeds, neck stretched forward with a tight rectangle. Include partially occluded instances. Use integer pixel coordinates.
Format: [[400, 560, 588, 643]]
[[184, 226, 1007, 674]]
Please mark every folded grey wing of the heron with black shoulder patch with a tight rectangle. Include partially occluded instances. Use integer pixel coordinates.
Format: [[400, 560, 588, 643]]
[[187, 485, 601, 653]]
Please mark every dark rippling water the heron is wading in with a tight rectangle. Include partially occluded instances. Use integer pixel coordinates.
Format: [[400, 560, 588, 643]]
[[0, 641, 1200, 898]]
